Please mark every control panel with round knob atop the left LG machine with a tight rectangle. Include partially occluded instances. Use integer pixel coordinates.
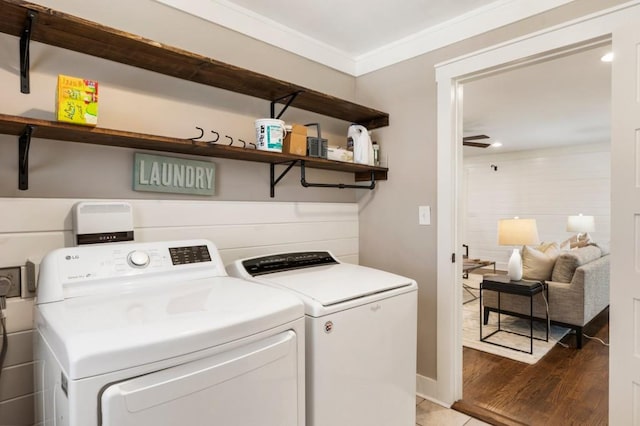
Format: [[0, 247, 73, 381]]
[[36, 240, 227, 303]]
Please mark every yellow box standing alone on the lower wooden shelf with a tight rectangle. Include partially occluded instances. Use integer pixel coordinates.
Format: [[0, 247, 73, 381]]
[[56, 75, 98, 126]]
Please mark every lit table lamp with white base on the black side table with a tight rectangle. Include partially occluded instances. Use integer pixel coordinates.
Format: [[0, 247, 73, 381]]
[[498, 217, 539, 281]]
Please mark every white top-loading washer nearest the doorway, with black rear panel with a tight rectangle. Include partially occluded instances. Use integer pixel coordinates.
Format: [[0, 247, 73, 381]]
[[227, 251, 417, 426]]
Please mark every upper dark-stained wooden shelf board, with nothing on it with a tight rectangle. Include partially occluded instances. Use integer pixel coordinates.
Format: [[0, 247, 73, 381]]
[[0, 0, 389, 129]]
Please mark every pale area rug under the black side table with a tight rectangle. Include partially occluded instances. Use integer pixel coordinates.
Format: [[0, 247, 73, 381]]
[[462, 274, 570, 364]]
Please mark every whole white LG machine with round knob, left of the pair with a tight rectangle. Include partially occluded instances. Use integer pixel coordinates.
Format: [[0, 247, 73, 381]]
[[35, 240, 305, 426]]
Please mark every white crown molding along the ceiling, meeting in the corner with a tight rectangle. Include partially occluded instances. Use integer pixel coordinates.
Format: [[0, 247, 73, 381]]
[[155, 0, 574, 77]]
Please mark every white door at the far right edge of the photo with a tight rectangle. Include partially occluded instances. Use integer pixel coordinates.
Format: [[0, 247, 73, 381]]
[[609, 8, 640, 425]]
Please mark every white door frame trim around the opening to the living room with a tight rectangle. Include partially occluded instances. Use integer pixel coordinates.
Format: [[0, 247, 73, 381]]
[[433, 0, 640, 406]]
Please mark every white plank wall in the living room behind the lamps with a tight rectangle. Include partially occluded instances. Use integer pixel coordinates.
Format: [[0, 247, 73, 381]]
[[460, 143, 611, 270]]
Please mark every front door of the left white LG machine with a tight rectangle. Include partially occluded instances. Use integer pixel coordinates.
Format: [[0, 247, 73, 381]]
[[101, 331, 303, 426]]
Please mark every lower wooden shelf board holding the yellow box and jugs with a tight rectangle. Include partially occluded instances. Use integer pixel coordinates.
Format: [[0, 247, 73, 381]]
[[0, 114, 388, 181]]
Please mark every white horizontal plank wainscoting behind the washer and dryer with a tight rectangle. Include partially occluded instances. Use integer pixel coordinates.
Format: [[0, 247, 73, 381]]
[[0, 198, 359, 425]]
